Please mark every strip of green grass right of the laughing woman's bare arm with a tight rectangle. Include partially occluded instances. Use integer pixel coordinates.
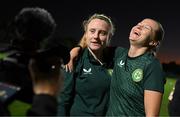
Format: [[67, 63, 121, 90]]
[[160, 78, 176, 116]]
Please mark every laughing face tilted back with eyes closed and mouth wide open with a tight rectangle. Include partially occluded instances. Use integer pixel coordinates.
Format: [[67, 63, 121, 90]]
[[129, 19, 158, 47]]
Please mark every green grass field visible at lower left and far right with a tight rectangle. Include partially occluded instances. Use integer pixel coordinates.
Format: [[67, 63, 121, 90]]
[[9, 78, 176, 116]]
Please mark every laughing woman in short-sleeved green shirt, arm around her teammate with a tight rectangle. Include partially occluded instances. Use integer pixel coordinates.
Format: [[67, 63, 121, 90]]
[[66, 18, 165, 116]]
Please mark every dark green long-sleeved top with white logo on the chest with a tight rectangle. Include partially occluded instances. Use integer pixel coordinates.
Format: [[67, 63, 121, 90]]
[[58, 49, 114, 116]]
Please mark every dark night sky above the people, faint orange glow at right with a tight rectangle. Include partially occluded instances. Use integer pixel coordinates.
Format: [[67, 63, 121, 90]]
[[0, 0, 180, 64]]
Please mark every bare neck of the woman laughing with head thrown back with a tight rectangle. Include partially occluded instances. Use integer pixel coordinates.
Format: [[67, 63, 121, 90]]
[[128, 45, 148, 57]]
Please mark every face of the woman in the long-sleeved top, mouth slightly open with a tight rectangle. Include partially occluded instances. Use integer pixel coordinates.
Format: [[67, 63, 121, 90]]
[[85, 19, 110, 51]]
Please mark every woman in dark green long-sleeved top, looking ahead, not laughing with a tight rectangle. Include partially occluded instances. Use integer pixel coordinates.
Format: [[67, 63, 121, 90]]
[[58, 14, 114, 116]]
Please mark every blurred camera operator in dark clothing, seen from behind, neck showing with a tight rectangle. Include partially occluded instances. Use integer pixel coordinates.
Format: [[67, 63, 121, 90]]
[[27, 56, 64, 116]]
